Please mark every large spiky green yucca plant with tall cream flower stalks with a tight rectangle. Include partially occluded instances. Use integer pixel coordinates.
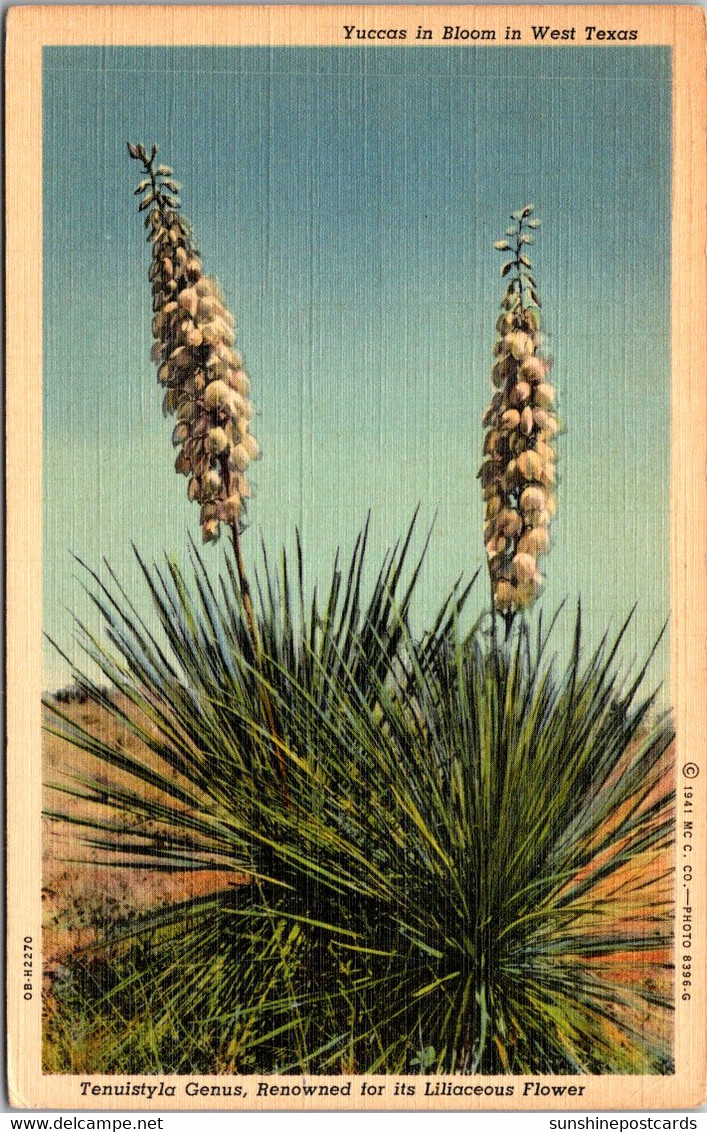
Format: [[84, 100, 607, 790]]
[[45, 187, 672, 1074]]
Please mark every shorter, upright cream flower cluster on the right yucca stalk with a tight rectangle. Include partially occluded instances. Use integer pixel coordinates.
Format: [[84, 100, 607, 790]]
[[478, 205, 558, 618]]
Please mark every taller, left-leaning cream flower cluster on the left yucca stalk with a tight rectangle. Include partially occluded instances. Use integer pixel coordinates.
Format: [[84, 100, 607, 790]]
[[128, 144, 258, 542]]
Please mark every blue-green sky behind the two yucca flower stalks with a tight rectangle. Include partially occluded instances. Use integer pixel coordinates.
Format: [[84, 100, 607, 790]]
[[43, 45, 671, 687]]
